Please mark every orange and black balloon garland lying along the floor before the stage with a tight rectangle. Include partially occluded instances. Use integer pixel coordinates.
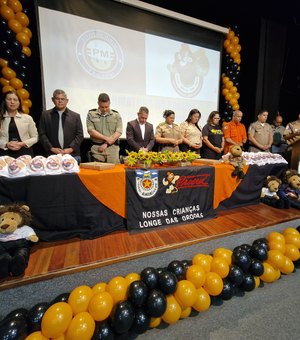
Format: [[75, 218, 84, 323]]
[[0, 226, 300, 340]]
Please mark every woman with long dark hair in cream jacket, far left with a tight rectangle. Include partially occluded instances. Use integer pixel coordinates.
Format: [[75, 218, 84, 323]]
[[0, 91, 38, 158]]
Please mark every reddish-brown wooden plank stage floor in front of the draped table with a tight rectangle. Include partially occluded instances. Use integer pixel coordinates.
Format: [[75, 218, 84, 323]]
[[0, 203, 300, 290]]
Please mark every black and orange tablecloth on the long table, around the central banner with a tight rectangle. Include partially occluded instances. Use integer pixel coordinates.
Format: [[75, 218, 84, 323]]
[[0, 164, 286, 242]]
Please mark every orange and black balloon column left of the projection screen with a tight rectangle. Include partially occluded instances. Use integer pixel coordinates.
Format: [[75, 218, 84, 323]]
[[0, 0, 32, 113]]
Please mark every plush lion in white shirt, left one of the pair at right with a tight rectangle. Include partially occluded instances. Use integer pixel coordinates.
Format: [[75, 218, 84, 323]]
[[260, 176, 290, 209]]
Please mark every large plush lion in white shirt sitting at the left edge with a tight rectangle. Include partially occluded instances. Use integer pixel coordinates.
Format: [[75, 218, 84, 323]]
[[0, 204, 39, 279]]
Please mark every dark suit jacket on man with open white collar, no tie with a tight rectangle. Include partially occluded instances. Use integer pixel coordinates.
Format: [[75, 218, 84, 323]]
[[126, 119, 155, 151]]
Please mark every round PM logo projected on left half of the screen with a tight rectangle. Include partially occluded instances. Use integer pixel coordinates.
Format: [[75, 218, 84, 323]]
[[76, 30, 124, 79]]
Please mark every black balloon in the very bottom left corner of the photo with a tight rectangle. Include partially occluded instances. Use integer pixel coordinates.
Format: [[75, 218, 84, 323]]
[[0, 319, 29, 340]]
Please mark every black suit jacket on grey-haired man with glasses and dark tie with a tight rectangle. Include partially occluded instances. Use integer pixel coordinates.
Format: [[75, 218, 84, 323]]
[[38, 108, 83, 156]]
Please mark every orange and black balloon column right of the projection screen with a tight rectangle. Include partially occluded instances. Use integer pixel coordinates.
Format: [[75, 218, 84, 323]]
[[222, 27, 241, 121]]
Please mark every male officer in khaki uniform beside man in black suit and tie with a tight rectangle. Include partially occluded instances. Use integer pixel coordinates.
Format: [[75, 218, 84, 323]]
[[86, 93, 122, 164]]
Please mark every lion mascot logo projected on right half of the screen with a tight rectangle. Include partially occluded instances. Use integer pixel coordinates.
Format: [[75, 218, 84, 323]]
[[168, 44, 209, 98]]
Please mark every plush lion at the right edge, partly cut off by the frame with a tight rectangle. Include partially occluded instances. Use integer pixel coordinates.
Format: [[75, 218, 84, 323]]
[[278, 169, 300, 209]]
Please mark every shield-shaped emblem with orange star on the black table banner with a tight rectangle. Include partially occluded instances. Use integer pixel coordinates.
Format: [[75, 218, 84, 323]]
[[135, 170, 158, 198]]
